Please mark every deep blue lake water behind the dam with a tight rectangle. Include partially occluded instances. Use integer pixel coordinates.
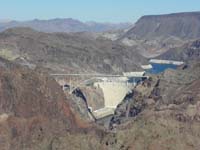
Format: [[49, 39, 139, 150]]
[[146, 63, 177, 74]]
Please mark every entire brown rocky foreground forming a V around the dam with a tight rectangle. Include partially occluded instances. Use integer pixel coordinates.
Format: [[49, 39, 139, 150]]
[[0, 48, 200, 150]]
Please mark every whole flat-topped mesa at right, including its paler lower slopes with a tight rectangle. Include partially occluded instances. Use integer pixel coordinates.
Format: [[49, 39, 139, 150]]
[[119, 12, 200, 57]]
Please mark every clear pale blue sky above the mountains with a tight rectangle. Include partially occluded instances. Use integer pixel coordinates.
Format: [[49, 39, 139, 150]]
[[0, 0, 200, 23]]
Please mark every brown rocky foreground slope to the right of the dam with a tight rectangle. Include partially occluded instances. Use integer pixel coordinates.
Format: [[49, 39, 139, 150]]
[[103, 63, 200, 150]]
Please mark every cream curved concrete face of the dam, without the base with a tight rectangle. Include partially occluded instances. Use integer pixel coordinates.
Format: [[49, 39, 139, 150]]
[[95, 82, 132, 108]]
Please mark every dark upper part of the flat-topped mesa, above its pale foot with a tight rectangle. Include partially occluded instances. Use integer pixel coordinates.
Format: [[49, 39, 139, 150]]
[[126, 12, 200, 39]]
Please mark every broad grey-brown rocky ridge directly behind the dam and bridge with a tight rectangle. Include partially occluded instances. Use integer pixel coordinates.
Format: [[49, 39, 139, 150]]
[[0, 28, 146, 73]]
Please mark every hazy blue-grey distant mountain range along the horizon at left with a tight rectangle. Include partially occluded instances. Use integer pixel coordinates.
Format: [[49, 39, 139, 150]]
[[0, 18, 132, 33]]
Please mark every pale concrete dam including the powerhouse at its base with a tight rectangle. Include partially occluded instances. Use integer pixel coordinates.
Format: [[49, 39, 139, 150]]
[[92, 72, 148, 119]]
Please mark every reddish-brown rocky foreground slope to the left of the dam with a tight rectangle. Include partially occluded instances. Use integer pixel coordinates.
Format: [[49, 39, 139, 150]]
[[0, 59, 107, 150]]
